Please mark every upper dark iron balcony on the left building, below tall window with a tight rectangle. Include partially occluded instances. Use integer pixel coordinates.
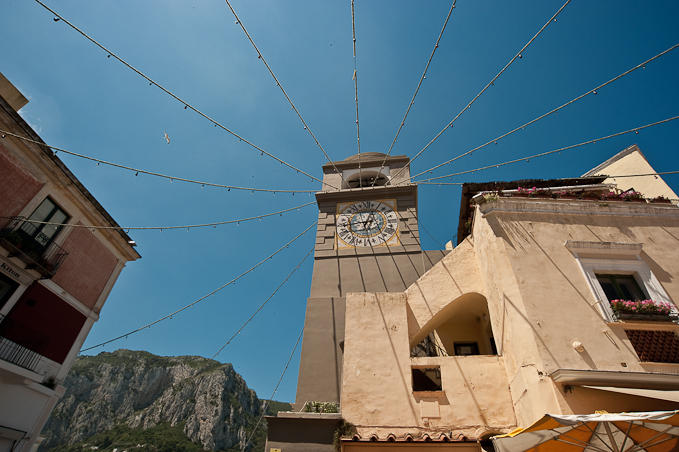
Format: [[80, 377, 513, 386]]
[[0, 217, 68, 279]]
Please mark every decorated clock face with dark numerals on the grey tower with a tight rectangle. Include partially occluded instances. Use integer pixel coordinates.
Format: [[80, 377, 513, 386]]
[[337, 200, 398, 248]]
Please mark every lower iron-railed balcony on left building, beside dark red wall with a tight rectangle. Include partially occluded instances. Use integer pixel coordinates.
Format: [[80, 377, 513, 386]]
[[0, 314, 50, 372]]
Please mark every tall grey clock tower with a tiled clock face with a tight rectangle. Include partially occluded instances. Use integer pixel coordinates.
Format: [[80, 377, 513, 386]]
[[266, 152, 447, 451]]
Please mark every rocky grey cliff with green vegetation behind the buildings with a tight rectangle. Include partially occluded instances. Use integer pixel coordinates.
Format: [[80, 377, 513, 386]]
[[39, 350, 290, 452]]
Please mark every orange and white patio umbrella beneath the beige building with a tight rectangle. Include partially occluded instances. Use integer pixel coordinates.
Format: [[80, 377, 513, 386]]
[[493, 411, 679, 452]]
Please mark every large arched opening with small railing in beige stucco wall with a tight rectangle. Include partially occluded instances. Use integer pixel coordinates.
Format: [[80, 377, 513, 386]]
[[410, 293, 497, 357]]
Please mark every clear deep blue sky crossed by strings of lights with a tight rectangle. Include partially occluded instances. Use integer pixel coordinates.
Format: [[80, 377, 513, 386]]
[[0, 0, 679, 401]]
